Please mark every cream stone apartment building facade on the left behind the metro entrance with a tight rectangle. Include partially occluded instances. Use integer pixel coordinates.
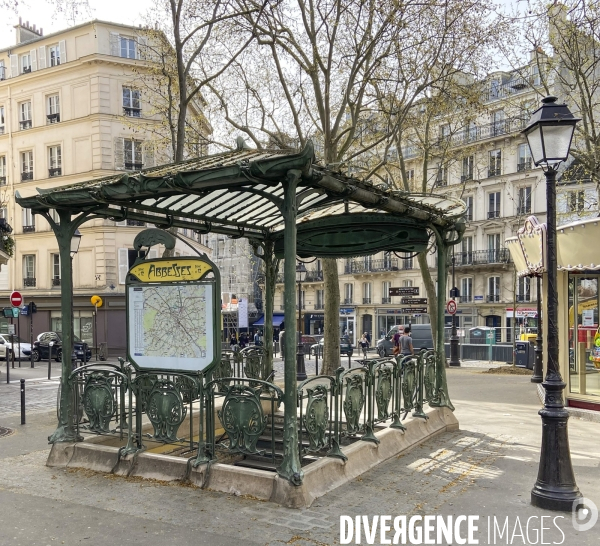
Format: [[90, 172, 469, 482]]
[[0, 21, 209, 354]]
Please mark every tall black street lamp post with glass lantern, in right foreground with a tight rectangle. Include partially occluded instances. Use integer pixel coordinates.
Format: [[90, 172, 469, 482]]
[[523, 97, 581, 511]]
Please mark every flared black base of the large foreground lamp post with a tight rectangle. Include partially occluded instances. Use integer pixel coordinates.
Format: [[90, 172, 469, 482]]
[[531, 381, 582, 512]]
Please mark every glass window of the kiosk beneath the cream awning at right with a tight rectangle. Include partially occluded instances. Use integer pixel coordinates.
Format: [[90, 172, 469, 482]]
[[569, 275, 600, 396]]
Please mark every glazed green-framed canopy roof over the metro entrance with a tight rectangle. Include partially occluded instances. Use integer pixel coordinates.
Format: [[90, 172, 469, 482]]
[[16, 138, 466, 240]]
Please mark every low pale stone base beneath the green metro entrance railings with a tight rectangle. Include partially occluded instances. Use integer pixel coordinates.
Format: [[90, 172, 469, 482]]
[[46, 408, 458, 508]]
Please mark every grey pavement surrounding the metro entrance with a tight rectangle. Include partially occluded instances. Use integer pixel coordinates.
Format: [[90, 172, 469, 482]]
[[0, 361, 600, 546]]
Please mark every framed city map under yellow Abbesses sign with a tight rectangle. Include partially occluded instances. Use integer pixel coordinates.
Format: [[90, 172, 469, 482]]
[[127, 258, 221, 371]]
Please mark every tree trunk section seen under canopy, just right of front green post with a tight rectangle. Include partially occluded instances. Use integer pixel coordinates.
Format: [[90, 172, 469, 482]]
[[321, 258, 340, 375]]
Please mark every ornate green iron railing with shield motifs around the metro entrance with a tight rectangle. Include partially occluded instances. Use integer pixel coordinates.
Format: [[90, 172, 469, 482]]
[[58, 347, 438, 469]]
